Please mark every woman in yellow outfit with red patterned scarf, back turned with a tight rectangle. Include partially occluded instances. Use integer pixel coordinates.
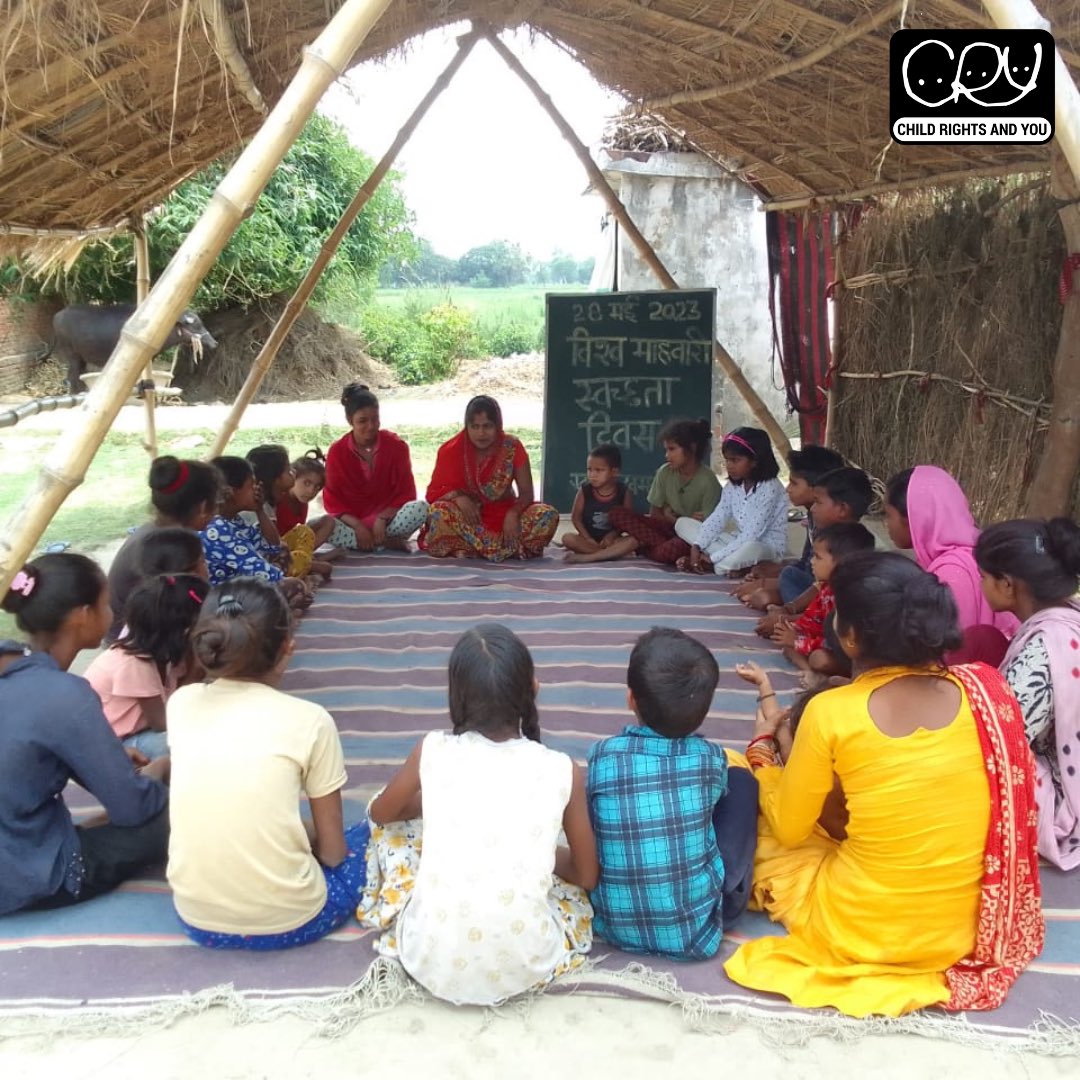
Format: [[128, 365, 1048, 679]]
[[725, 552, 1044, 1016]]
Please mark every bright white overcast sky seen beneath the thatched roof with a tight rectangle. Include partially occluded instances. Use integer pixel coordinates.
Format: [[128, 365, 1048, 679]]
[[320, 27, 622, 258]]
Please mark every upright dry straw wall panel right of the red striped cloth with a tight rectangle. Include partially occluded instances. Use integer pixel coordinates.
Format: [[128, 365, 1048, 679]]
[[835, 179, 1067, 522]]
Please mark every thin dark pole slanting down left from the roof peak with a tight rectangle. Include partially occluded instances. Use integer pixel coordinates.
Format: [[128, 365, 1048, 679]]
[[207, 30, 481, 458]]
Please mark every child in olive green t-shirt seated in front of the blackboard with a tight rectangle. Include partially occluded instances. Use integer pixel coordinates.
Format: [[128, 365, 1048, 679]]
[[566, 420, 720, 564]]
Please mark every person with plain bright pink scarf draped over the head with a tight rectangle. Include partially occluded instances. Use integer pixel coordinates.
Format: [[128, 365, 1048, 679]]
[[885, 465, 1020, 667]]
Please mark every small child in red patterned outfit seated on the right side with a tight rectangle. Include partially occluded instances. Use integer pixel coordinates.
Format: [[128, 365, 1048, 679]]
[[772, 522, 874, 686]]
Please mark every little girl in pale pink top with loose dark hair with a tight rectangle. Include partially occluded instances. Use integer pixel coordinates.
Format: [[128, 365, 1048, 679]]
[[86, 573, 210, 760]]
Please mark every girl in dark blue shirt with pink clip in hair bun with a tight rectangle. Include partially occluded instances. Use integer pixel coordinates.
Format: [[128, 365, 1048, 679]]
[[0, 553, 168, 915]]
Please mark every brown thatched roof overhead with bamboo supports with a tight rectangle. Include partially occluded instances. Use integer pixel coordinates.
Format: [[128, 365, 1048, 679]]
[[0, 0, 1080, 249]]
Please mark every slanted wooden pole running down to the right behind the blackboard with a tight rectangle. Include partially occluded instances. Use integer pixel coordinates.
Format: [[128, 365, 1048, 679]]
[[484, 30, 792, 456]]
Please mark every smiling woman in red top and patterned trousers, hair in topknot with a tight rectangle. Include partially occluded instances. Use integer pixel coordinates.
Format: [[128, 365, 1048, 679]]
[[323, 382, 428, 551]]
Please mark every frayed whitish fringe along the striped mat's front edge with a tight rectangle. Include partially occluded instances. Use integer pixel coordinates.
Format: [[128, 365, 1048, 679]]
[[0, 957, 1080, 1057]]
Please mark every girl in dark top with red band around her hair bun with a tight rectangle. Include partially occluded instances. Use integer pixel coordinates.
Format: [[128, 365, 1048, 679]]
[[106, 454, 221, 644]]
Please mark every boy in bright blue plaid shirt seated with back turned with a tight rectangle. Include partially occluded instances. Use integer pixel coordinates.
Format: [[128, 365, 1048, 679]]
[[588, 627, 757, 960]]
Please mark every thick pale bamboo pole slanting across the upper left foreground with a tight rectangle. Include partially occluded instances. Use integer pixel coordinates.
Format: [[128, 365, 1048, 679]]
[[0, 0, 391, 595]]
